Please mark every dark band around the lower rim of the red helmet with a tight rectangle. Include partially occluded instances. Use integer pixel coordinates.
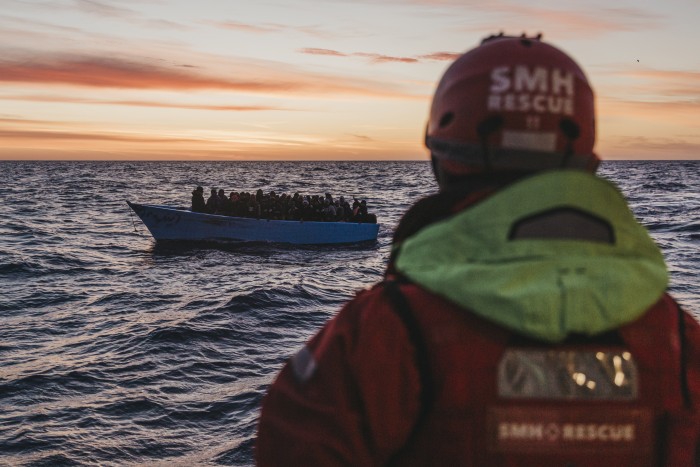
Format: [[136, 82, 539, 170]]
[[425, 135, 595, 170]]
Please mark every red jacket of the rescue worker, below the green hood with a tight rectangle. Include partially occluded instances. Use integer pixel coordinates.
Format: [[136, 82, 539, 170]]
[[256, 174, 700, 466]]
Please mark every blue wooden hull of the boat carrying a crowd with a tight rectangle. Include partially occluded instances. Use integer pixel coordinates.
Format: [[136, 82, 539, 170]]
[[127, 201, 379, 245]]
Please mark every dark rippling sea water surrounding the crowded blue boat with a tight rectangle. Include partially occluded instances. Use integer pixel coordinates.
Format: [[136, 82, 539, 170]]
[[0, 162, 700, 465]]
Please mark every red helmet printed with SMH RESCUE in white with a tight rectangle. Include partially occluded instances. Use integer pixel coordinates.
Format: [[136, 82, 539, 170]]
[[425, 34, 600, 178]]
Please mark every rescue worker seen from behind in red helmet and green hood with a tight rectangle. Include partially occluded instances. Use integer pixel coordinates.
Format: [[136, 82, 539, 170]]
[[256, 35, 700, 467]]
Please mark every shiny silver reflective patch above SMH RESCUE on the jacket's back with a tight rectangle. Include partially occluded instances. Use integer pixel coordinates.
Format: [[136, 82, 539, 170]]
[[497, 348, 639, 401]]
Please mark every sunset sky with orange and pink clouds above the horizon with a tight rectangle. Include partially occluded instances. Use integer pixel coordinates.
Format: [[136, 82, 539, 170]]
[[0, 0, 700, 160]]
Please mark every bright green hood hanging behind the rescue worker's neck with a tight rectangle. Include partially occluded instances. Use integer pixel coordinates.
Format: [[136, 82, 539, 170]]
[[396, 171, 668, 342]]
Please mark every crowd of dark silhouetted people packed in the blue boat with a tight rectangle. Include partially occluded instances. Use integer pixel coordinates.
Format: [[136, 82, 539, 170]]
[[192, 186, 377, 224]]
